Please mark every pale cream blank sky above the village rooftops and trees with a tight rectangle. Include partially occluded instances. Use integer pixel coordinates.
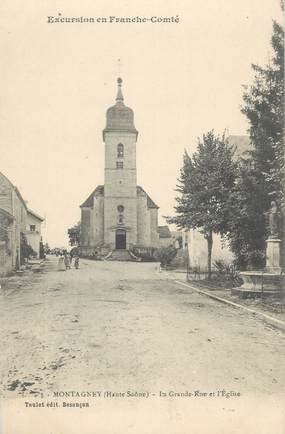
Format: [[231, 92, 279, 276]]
[[0, 0, 281, 246]]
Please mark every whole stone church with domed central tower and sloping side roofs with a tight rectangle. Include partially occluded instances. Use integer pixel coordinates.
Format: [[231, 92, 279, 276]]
[[80, 78, 159, 255]]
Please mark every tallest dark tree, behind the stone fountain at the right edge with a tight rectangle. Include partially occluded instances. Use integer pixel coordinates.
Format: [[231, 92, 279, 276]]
[[228, 13, 285, 268]]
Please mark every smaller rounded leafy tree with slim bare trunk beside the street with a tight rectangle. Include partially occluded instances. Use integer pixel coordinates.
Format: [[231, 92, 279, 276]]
[[167, 130, 237, 279]]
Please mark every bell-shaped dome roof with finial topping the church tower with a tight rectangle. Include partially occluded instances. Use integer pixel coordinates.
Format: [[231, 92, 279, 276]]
[[103, 78, 138, 139]]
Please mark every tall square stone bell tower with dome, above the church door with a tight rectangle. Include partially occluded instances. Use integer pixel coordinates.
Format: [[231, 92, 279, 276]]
[[103, 78, 138, 250]]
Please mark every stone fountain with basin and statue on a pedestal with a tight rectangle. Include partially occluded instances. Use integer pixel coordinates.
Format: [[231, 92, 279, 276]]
[[232, 201, 285, 297]]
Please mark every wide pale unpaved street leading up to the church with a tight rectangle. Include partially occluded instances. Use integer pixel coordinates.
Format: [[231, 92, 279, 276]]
[[0, 257, 285, 397]]
